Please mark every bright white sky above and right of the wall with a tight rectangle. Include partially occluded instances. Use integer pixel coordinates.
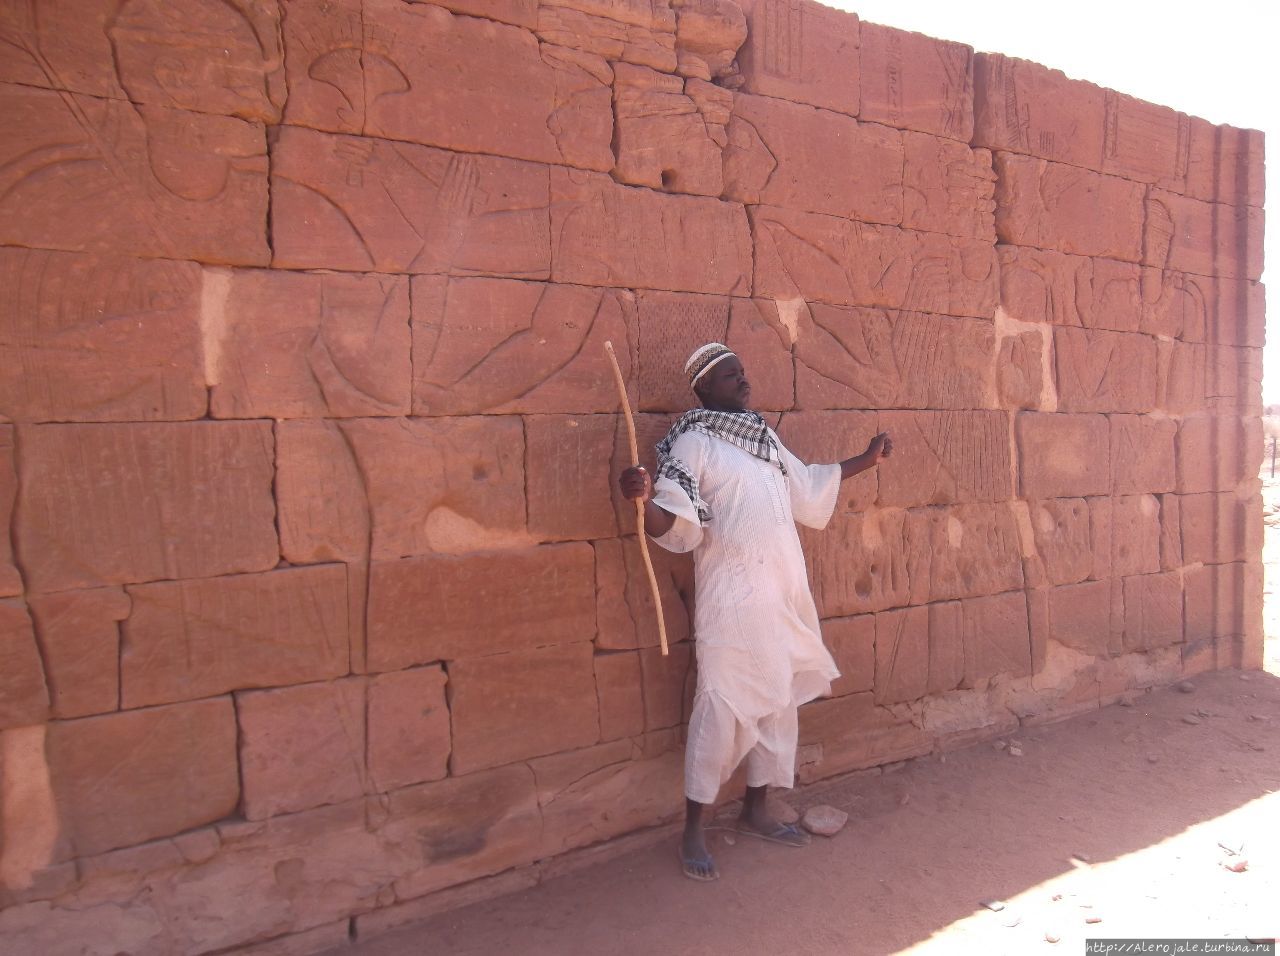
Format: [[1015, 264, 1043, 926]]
[[826, 0, 1280, 404]]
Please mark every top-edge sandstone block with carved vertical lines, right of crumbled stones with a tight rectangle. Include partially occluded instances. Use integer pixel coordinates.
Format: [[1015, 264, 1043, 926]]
[[737, 0, 860, 116]]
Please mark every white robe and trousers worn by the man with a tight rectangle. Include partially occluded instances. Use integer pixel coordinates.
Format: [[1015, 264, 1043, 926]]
[[654, 430, 840, 804]]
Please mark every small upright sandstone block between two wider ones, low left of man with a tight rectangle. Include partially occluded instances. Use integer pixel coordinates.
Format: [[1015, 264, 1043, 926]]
[[366, 667, 452, 791]]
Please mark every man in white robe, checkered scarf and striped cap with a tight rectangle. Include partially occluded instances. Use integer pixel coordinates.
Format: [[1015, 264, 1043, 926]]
[[618, 342, 893, 880]]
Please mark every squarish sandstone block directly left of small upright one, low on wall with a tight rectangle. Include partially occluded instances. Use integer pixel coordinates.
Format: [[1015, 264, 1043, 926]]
[[236, 677, 366, 820]]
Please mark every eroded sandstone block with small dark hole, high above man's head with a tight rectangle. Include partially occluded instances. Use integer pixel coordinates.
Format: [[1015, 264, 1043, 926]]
[[613, 63, 732, 198]]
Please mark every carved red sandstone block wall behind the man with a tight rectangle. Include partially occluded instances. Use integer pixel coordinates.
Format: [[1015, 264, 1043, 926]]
[[0, 0, 1263, 953]]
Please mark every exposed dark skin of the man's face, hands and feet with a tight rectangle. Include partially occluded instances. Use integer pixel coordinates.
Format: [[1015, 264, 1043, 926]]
[[618, 356, 893, 879]]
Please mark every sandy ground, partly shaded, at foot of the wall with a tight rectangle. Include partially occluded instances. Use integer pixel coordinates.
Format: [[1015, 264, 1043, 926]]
[[327, 486, 1280, 956]]
